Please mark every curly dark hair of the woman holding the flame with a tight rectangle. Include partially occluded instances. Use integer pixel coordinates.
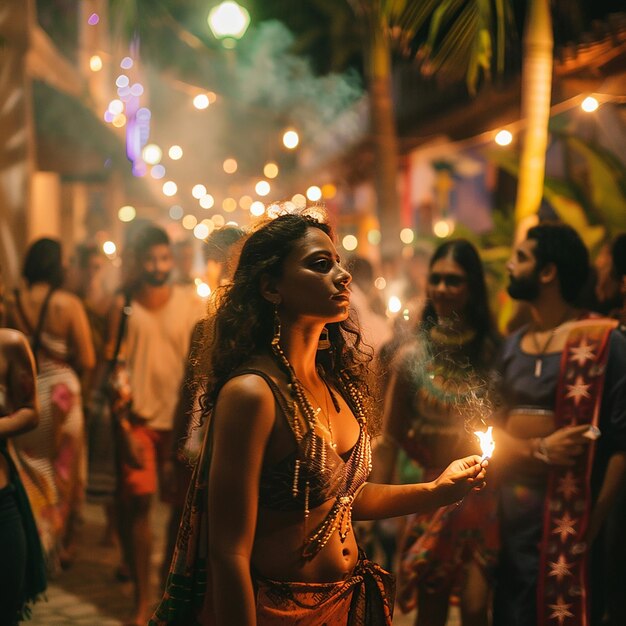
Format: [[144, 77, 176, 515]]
[[198, 211, 372, 428]]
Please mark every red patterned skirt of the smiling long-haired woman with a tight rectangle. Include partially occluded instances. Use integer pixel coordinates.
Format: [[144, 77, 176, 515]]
[[397, 476, 500, 613]]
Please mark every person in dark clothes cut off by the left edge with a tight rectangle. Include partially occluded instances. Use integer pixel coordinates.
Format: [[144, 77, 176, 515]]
[[0, 270, 46, 626]]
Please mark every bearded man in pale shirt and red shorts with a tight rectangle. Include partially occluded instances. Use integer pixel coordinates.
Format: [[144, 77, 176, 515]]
[[109, 226, 204, 624]]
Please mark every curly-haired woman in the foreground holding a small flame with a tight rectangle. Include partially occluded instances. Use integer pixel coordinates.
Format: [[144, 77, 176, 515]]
[[151, 209, 485, 626]]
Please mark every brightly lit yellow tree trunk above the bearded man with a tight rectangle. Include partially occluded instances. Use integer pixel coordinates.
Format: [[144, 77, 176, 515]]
[[515, 0, 554, 241]]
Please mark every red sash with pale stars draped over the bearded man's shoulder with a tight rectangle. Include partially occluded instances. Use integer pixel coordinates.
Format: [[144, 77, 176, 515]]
[[537, 320, 616, 626]]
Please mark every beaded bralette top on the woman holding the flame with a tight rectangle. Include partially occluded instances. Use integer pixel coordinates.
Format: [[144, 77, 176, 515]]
[[236, 369, 372, 558]]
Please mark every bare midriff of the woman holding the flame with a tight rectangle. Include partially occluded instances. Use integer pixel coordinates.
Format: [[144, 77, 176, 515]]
[[252, 498, 358, 583]]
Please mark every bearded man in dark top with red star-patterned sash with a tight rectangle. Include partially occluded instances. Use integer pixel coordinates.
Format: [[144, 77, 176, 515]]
[[493, 224, 626, 626]]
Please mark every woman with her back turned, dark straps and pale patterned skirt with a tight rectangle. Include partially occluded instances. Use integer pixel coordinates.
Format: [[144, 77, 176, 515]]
[[9, 239, 95, 567]]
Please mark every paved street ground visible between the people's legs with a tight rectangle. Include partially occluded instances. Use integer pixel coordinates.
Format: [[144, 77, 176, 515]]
[[25, 505, 459, 626]]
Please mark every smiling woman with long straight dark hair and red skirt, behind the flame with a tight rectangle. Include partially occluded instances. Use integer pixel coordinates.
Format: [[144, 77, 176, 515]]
[[373, 239, 498, 626]]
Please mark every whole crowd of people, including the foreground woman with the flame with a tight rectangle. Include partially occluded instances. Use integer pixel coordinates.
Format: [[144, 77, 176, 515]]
[[0, 207, 626, 626]]
